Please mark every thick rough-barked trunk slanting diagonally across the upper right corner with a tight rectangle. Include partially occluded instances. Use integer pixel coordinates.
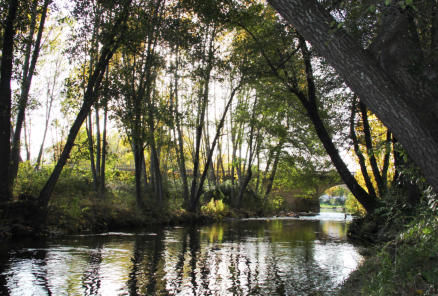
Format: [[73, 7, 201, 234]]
[[269, 0, 438, 197]]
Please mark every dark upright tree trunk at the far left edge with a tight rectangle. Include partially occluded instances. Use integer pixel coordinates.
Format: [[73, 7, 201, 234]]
[[0, 0, 18, 202]]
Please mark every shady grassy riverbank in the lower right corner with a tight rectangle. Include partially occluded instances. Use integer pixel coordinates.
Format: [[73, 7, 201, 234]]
[[338, 215, 438, 296]]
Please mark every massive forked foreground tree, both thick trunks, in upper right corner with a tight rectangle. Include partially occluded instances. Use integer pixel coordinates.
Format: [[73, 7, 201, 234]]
[[269, 0, 438, 197]]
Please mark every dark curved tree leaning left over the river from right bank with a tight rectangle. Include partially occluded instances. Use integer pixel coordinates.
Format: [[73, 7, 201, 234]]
[[231, 4, 377, 212]]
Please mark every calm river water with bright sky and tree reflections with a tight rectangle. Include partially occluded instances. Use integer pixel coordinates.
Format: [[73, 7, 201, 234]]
[[0, 213, 362, 296]]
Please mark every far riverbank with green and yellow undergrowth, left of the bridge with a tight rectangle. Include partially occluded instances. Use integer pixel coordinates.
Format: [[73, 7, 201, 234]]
[[0, 195, 270, 241]]
